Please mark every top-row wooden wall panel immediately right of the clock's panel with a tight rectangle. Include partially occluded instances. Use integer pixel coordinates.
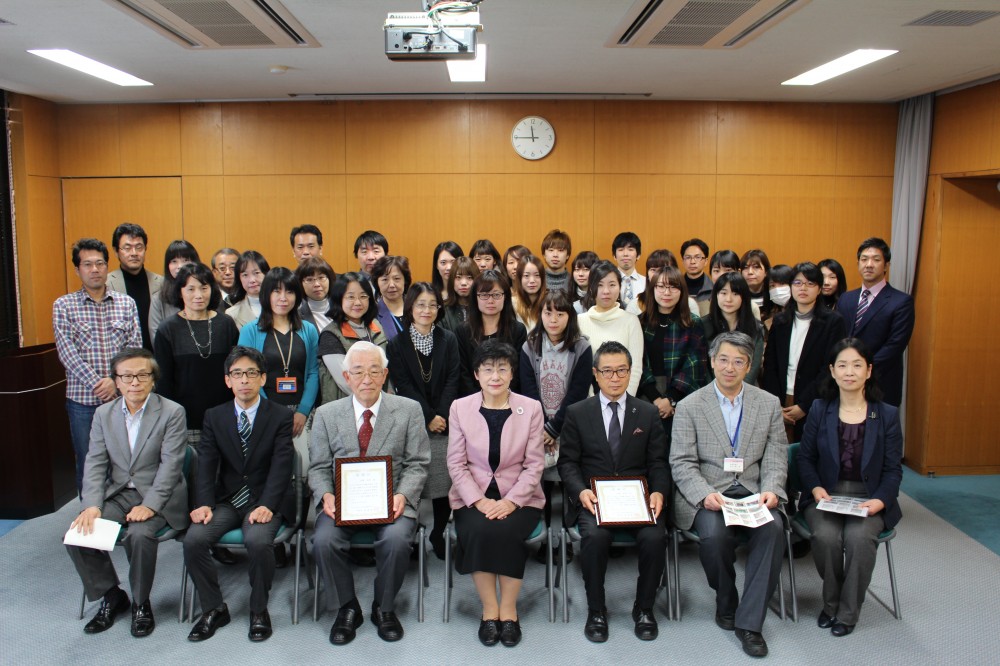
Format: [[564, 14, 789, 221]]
[[594, 102, 719, 174]]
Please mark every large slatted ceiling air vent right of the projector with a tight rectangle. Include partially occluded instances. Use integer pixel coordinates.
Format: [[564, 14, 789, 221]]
[[606, 0, 809, 49]]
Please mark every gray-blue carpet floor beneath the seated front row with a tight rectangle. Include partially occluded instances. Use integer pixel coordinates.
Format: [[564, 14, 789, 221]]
[[0, 495, 1000, 666]]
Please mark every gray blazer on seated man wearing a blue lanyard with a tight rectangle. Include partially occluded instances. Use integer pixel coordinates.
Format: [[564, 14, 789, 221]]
[[670, 382, 788, 529]]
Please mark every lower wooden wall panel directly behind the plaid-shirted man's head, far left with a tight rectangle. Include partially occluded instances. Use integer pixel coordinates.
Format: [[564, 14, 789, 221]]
[[62, 178, 183, 291]]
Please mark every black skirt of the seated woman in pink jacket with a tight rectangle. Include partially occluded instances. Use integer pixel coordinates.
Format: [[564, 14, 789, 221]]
[[455, 506, 542, 578]]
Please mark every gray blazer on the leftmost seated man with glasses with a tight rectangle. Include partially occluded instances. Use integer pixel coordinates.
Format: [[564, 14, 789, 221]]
[[82, 393, 190, 529]]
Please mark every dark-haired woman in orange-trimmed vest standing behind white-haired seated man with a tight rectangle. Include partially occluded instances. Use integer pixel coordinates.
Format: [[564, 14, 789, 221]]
[[319, 272, 388, 404]]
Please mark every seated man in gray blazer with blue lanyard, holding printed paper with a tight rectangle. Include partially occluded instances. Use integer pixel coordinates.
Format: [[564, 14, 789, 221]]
[[670, 332, 788, 657]]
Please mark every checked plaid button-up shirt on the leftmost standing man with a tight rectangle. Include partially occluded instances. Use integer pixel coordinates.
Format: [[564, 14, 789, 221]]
[[52, 288, 142, 406]]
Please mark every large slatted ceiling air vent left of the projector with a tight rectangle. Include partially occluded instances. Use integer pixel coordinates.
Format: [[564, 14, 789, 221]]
[[105, 0, 319, 49]]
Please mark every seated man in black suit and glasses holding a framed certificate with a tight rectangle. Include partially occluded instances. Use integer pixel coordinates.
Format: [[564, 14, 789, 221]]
[[559, 341, 670, 643]]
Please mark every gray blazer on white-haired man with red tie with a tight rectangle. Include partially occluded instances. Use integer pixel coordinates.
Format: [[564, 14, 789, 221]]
[[309, 391, 431, 519]]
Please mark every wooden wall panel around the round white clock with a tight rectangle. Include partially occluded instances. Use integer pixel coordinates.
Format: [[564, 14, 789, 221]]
[[470, 100, 594, 173]]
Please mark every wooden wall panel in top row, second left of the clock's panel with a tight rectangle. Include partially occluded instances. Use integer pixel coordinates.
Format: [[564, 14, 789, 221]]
[[222, 102, 344, 175]]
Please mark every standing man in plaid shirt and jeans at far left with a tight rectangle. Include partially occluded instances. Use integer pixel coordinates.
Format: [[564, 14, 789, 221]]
[[52, 238, 143, 492]]
